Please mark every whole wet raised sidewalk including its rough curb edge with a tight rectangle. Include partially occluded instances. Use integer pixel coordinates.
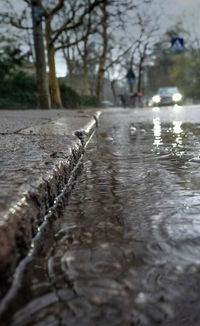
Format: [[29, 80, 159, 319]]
[[0, 110, 100, 280]]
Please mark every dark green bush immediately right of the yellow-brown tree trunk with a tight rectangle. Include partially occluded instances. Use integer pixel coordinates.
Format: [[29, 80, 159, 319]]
[[60, 83, 80, 109]]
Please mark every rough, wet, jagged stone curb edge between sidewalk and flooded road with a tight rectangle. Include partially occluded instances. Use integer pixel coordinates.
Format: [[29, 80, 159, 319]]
[[0, 112, 101, 282]]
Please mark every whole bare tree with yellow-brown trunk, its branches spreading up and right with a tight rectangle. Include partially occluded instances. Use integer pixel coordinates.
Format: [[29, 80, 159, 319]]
[[1, 0, 106, 108]]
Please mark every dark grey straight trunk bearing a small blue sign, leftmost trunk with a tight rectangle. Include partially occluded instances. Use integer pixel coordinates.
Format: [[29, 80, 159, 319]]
[[32, 0, 51, 109]]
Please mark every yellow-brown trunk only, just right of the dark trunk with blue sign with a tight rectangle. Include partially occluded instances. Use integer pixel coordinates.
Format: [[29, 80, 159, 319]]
[[46, 18, 62, 109]]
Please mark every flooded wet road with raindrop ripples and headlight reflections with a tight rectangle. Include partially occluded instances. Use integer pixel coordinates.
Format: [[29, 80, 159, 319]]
[[0, 107, 200, 326]]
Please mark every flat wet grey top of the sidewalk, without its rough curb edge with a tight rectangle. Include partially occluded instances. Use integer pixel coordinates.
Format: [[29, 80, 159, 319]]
[[0, 110, 95, 221]]
